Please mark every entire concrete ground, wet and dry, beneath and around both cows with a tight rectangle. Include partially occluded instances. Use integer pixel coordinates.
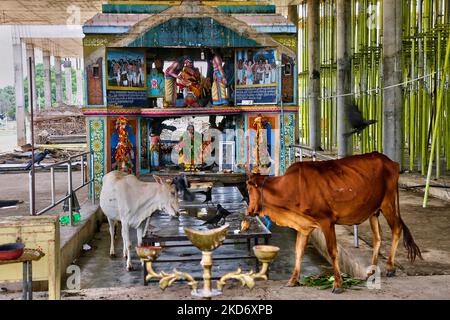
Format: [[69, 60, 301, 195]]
[[0, 173, 450, 299]]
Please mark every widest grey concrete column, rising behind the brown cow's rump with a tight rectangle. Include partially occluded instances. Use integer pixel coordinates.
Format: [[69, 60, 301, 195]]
[[383, 1, 403, 164]]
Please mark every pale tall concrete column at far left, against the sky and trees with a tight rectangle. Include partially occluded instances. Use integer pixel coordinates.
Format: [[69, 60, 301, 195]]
[[12, 28, 27, 146]]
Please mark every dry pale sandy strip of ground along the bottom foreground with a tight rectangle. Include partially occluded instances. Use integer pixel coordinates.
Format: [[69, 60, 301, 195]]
[[0, 275, 450, 300]]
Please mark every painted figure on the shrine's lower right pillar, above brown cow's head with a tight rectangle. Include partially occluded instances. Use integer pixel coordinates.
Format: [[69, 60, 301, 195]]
[[252, 114, 271, 174]]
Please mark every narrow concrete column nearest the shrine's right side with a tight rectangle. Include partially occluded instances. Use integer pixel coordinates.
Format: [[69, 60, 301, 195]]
[[307, 0, 321, 149]]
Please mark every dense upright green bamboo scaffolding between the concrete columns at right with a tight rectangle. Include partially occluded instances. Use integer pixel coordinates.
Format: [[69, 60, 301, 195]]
[[299, 0, 450, 178]]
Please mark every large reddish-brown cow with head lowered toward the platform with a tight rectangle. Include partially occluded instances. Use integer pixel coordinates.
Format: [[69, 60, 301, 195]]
[[247, 152, 422, 293]]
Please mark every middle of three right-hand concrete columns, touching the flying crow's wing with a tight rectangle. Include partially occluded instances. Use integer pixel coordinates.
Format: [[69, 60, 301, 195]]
[[336, 0, 352, 158]]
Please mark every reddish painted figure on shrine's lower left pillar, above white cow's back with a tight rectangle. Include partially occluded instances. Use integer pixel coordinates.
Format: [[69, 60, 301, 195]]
[[114, 116, 134, 174]]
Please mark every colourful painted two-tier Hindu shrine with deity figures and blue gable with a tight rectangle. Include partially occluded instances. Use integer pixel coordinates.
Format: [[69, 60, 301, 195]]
[[83, 1, 298, 194]]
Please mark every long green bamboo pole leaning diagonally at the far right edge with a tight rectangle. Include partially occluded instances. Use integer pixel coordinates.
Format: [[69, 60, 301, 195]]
[[423, 33, 450, 208]]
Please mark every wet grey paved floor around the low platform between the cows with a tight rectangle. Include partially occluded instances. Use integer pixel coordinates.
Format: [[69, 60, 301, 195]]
[[73, 224, 330, 289]]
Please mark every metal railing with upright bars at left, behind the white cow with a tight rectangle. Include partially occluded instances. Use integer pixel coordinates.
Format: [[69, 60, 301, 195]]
[[29, 151, 95, 225]]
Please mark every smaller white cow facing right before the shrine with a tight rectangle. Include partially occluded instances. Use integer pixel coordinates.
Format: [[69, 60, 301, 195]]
[[100, 171, 179, 271]]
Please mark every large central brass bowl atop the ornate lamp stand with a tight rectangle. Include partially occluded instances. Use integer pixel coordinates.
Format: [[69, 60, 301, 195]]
[[184, 224, 230, 251]]
